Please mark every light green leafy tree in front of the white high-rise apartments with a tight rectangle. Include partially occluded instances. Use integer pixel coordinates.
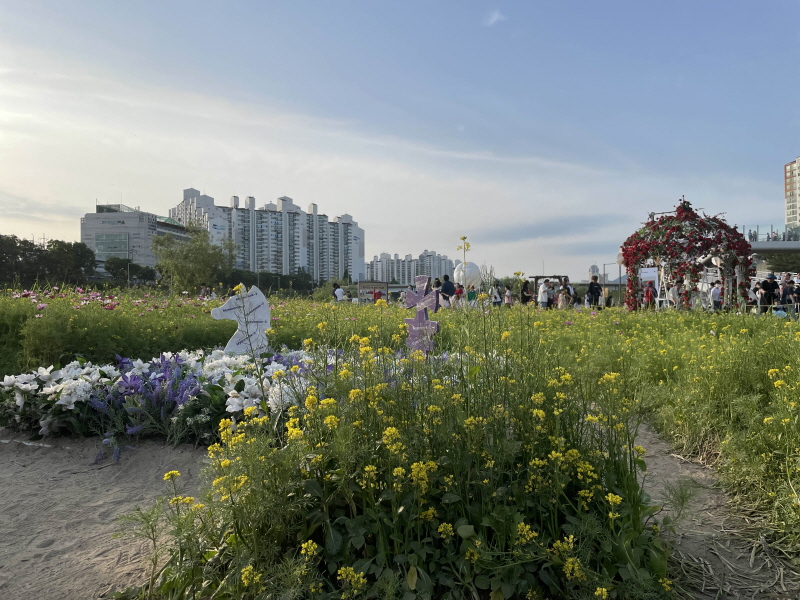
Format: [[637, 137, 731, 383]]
[[153, 228, 232, 290]]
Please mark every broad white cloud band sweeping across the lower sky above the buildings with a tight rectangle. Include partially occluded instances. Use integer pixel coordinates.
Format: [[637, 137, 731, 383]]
[[0, 38, 780, 275]]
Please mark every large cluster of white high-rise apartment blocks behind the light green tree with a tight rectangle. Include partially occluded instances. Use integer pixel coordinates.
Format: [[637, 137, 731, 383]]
[[170, 188, 365, 281]]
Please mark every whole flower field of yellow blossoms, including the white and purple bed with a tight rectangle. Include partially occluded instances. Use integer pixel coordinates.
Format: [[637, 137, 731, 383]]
[[0, 291, 800, 600]]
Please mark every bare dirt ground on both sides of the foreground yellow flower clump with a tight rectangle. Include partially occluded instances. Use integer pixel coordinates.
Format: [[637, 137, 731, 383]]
[[0, 427, 800, 600]]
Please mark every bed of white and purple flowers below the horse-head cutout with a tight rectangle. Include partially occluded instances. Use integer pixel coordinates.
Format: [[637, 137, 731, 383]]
[[0, 350, 306, 452]]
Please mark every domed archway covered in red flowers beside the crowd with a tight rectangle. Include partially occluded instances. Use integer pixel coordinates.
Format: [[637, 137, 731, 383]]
[[621, 199, 753, 309]]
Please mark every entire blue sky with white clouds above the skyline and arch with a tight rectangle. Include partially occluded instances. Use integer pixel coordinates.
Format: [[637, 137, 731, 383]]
[[0, 0, 800, 279]]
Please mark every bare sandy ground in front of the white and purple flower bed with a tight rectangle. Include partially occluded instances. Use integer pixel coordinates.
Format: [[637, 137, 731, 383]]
[[0, 428, 205, 600]]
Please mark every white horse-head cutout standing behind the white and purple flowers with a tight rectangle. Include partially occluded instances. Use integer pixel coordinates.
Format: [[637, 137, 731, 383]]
[[211, 285, 270, 356]]
